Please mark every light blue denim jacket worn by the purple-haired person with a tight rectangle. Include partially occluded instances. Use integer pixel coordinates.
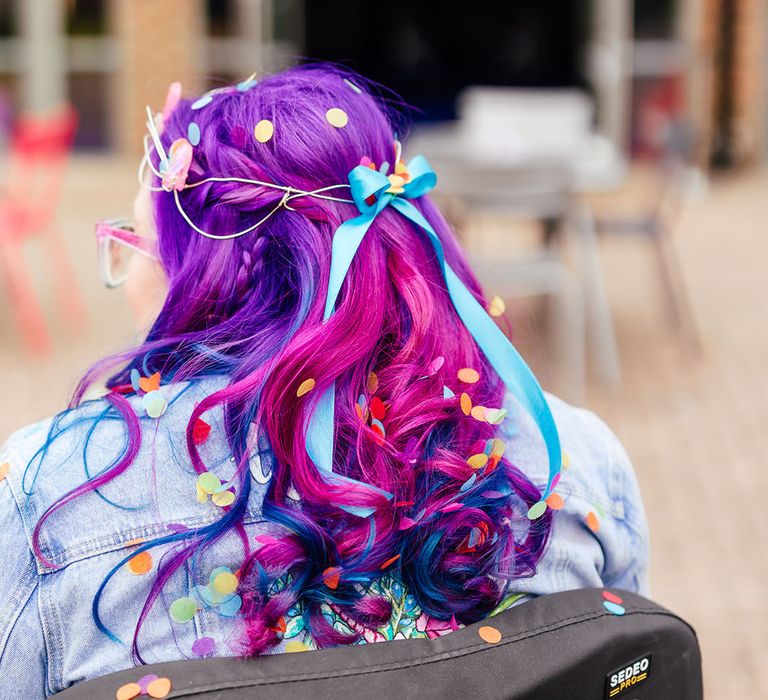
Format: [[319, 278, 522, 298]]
[[0, 377, 649, 700]]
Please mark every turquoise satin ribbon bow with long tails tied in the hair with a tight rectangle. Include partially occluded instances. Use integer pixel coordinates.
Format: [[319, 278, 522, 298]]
[[306, 156, 562, 517]]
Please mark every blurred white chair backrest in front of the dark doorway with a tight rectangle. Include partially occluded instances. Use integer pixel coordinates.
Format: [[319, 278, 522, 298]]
[[458, 86, 594, 162]]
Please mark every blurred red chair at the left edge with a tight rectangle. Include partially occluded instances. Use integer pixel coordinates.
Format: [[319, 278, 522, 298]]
[[0, 106, 85, 352]]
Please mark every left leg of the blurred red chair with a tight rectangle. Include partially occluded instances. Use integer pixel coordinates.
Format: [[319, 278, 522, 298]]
[[0, 241, 51, 354]]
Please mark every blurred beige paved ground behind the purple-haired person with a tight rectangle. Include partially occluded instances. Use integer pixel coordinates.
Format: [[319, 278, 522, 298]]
[[0, 158, 768, 700]]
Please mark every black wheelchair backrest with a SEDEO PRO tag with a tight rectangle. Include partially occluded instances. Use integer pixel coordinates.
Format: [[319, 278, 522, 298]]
[[55, 589, 702, 700]]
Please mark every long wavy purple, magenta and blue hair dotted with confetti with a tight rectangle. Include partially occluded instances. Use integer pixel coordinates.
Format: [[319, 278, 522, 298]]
[[35, 64, 552, 658]]
